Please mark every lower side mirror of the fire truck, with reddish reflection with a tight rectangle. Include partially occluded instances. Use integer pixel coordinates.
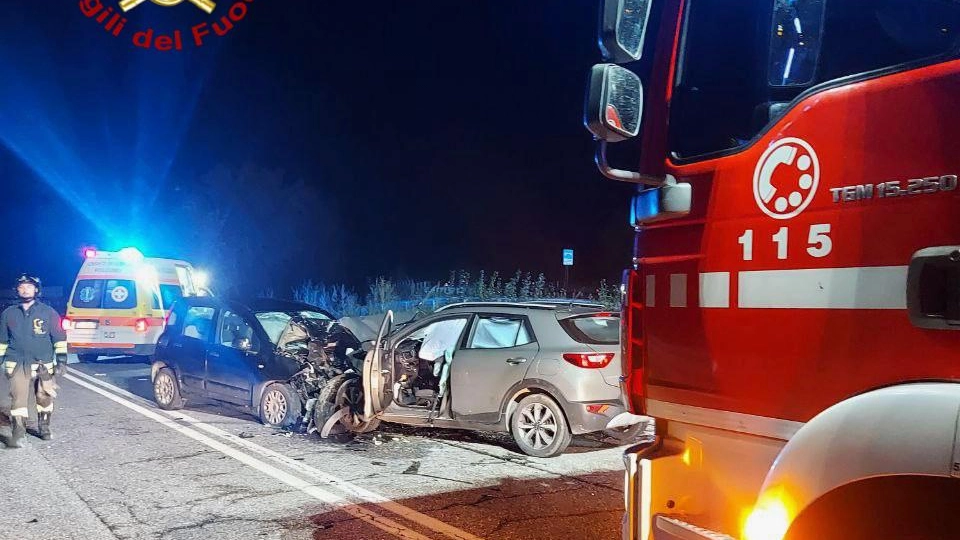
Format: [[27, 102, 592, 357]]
[[583, 64, 643, 142]]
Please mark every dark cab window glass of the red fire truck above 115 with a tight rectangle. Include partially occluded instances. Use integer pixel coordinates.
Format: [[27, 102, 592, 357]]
[[669, 0, 960, 160]]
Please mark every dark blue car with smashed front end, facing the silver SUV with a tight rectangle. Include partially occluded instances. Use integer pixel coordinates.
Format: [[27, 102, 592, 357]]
[[152, 296, 360, 428]]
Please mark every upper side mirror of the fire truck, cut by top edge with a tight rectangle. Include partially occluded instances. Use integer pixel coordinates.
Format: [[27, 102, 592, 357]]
[[598, 0, 653, 63]]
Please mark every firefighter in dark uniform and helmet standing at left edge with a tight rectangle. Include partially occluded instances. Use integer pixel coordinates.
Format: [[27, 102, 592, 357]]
[[0, 274, 67, 448]]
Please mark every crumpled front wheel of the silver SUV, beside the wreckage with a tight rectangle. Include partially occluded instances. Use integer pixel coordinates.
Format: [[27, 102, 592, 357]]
[[313, 373, 380, 442]]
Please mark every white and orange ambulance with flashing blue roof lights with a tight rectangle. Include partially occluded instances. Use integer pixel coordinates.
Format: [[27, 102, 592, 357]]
[[63, 248, 201, 362]]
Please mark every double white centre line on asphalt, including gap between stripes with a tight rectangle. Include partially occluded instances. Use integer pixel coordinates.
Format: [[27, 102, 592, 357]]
[[66, 371, 482, 540]]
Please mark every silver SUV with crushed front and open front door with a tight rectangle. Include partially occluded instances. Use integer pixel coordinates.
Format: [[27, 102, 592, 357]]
[[315, 302, 641, 457]]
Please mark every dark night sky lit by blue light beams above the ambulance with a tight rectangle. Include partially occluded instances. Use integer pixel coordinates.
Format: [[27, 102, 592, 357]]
[[0, 0, 631, 296]]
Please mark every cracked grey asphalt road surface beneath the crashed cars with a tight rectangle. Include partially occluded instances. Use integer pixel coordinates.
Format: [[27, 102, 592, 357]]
[[0, 359, 623, 540]]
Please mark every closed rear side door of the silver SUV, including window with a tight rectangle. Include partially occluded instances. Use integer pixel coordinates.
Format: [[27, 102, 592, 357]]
[[450, 313, 540, 422]]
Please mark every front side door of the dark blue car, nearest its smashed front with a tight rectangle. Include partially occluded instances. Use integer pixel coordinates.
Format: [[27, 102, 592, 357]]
[[206, 308, 260, 405]]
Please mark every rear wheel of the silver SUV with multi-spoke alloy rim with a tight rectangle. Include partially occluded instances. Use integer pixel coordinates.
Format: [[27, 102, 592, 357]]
[[510, 394, 571, 457]]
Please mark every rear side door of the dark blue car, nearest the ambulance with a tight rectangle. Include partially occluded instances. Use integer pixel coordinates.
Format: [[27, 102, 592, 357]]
[[170, 306, 217, 394]]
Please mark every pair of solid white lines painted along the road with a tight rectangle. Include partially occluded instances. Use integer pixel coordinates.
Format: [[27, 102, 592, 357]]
[[67, 370, 482, 540]]
